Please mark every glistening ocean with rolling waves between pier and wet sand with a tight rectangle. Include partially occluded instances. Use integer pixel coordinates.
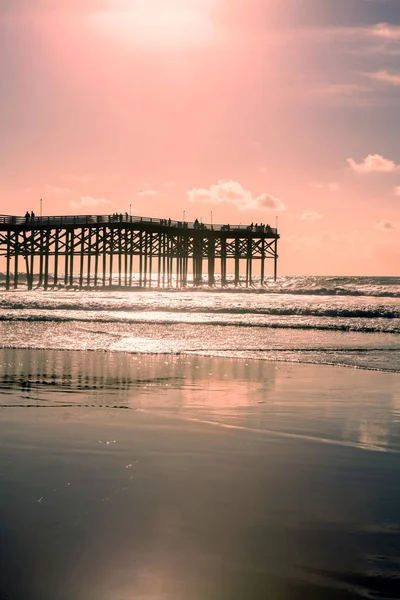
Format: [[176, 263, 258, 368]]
[[0, 276, 400, 372]]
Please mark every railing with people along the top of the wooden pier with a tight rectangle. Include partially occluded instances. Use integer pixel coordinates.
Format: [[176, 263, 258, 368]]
[[0, 213, 278, 235]]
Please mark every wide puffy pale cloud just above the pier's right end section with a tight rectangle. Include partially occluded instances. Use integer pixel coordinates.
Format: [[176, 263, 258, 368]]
[[187, 181, 286, 212]]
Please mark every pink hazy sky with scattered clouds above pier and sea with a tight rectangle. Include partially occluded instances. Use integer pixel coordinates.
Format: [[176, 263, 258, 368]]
[[0, 0, 400, 275]]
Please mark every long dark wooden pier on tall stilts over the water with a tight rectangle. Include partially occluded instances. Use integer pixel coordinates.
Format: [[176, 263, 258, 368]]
[[0, 213, 280, 289]]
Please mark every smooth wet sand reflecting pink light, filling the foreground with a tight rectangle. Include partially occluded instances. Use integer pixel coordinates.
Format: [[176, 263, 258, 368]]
[[0, 350, 400, 600]]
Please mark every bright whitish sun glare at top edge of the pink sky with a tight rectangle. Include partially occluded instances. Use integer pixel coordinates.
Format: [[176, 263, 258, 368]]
[[93, 0, 217, 45]]
